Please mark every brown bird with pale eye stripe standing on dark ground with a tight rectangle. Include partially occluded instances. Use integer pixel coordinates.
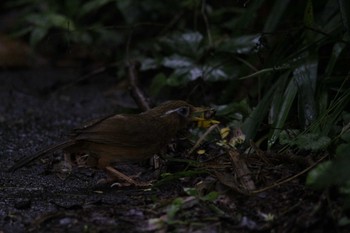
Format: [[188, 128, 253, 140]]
[[10, 100, 205, 184]]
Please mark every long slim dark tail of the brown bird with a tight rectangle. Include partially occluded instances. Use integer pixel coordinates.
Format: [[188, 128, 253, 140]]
[[8, 140, 75, 172]]
